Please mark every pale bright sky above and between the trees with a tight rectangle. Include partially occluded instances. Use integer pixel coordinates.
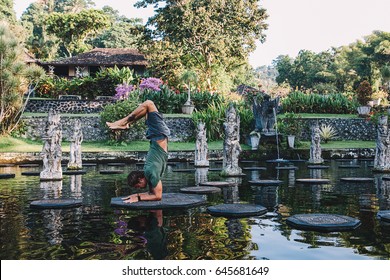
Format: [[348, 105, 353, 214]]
[[14, 0, 390, 67]]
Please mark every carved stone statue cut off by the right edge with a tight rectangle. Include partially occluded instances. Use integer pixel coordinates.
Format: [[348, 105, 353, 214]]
[[374, 116, 390, 172]]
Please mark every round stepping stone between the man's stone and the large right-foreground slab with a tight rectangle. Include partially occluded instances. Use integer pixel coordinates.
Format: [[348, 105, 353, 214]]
[[207, 203, 267, 218]]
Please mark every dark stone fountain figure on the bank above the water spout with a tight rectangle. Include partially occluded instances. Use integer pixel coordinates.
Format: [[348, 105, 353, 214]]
[[252, 94, 279, 134]]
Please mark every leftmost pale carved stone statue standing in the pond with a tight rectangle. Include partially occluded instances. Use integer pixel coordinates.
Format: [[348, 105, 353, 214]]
[[40, 109, 62, 181]]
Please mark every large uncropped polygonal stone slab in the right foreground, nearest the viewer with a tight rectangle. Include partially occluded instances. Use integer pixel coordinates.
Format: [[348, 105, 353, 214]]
[[286, 214, 360, 232]]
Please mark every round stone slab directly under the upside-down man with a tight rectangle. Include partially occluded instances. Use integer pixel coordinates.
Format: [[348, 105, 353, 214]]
[[111, 193, 207, 210]]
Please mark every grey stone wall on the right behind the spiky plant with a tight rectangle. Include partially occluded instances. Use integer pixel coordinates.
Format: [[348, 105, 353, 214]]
[[301, 118, 377, 141]]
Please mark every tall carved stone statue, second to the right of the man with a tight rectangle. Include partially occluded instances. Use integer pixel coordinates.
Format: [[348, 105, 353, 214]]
[[221, 104, 242, 176]]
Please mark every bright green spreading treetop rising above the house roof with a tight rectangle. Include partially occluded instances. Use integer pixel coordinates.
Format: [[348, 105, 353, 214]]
[[46, 9, 110, 57]]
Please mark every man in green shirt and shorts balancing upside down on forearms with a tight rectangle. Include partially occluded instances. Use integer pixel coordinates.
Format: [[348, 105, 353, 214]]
[[106, 100, 170, 203]]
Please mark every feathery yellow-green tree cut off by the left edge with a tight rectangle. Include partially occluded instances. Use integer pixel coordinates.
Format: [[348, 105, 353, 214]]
[[0, 23, 44, 135]]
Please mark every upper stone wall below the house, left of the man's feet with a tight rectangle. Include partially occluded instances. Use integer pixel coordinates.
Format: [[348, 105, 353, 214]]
[[25, 99, 115, 114]]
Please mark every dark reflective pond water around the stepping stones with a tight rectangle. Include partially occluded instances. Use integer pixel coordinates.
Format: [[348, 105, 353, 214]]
[[0, 160, 390, 260]]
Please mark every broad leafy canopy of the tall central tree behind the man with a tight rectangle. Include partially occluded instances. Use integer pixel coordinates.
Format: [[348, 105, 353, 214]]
[[136, 0, 267, 89]]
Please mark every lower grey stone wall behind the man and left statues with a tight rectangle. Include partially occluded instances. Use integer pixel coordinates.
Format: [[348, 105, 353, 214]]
[[23, 116, 195, 142]]
